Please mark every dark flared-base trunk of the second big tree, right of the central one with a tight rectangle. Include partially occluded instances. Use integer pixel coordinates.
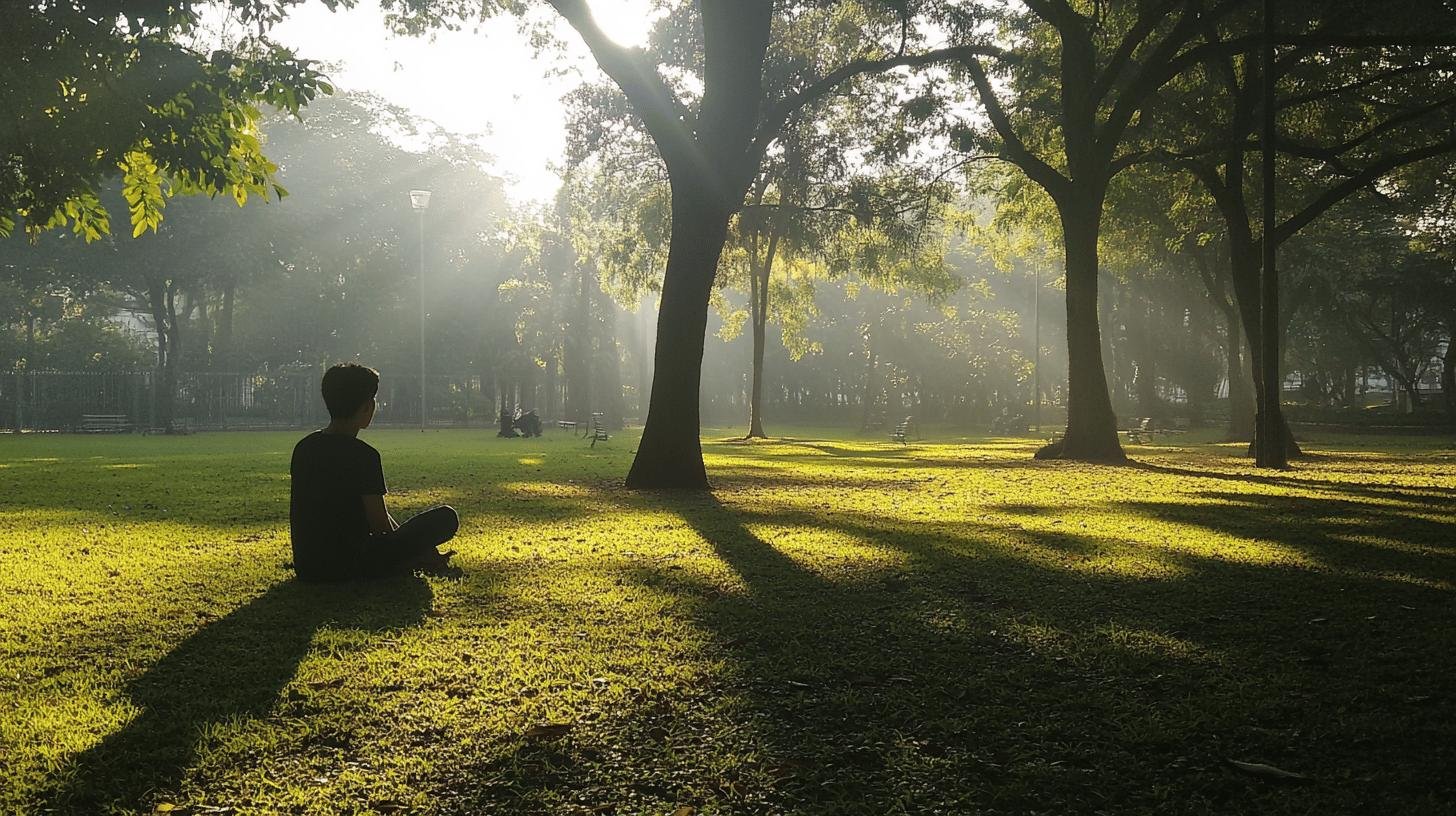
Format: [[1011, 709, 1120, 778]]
[[1037, 191, 1127, 462]]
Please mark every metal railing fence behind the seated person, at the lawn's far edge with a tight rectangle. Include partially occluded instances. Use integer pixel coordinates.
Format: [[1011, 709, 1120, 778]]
[[0, 370, 496, 431]]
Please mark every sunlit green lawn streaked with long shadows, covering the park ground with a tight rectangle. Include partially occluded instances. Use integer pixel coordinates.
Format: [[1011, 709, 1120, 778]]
[[0, 431, 1456, 815]]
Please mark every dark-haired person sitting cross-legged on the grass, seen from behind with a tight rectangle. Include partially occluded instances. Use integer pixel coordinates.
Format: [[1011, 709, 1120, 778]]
[[288, 363, 460, 581]]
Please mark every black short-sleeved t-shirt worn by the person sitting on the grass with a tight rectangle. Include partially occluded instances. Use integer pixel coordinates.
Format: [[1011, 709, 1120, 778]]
[[288, 431, 384, 580]]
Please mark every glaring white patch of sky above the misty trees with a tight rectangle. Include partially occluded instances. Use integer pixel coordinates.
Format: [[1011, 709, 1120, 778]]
[[272, 0, 651, 203]]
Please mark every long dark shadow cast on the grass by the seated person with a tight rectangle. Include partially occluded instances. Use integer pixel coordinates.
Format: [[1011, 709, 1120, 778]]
[[47, 577, 431, 813]]
